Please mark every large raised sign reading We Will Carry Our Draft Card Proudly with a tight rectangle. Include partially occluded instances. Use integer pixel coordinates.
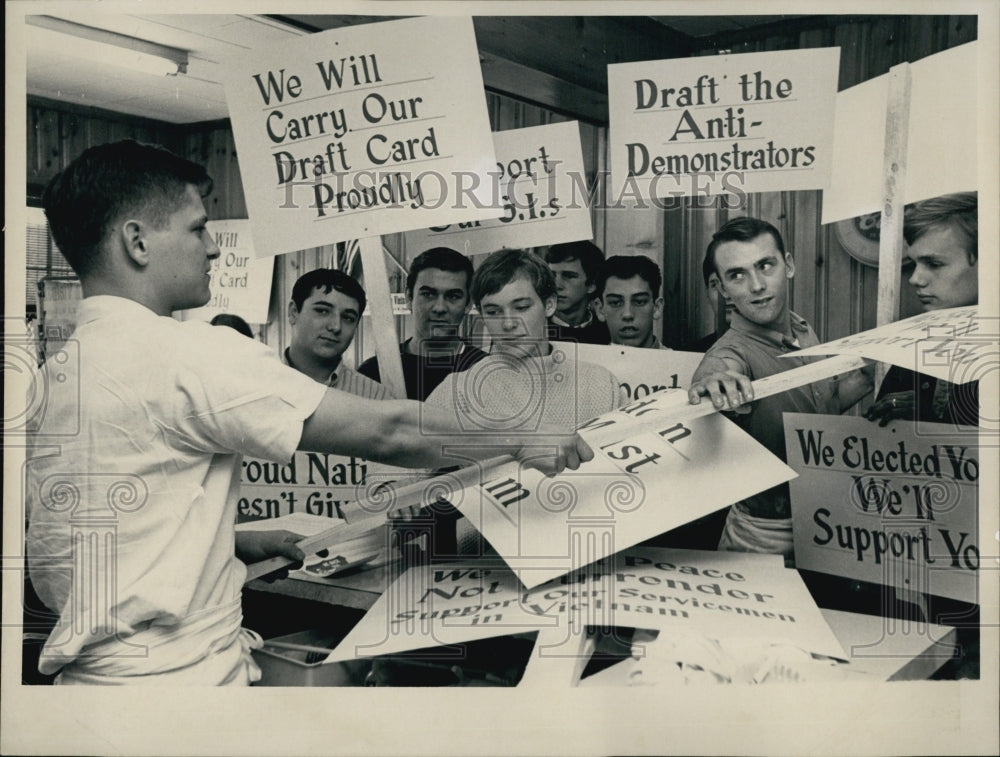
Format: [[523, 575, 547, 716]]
[[223, 17, 500, 256]]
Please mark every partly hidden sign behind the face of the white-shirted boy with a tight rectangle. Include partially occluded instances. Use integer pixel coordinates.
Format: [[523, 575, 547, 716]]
[[181, 219, 274, 323]]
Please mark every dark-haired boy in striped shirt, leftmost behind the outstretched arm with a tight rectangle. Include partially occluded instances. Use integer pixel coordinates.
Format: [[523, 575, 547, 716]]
[[282, 268, 392, 400]]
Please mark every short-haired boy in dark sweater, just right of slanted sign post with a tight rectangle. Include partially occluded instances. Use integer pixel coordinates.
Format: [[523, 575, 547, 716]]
[[358, 247, 486, 400]]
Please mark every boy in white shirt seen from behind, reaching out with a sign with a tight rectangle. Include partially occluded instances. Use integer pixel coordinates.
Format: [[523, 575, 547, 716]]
[[25, 141, 593, 685]]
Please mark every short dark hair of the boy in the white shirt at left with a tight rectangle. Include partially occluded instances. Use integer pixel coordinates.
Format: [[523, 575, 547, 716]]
[[42, 139, 212, 277]]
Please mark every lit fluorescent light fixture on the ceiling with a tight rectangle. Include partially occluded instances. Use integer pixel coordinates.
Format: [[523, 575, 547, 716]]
[[25, 16, 188, 76]]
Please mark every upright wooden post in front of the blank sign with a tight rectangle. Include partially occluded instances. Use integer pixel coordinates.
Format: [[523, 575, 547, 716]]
[[875, 63, 912, 392]]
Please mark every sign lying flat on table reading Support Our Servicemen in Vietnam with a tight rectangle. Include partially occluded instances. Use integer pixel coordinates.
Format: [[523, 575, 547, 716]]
[[328, 548, 844, 662]]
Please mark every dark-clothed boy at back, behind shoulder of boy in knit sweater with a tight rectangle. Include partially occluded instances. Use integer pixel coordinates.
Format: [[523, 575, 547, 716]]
[[545, 242, 611, 344]]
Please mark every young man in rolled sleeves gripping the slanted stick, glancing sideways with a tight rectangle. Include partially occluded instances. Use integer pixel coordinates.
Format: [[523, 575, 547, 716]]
[[688, 217, 871, 564]]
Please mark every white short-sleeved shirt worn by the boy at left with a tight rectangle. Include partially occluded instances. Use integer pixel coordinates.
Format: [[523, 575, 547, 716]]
[[27, 296, 327, 675]]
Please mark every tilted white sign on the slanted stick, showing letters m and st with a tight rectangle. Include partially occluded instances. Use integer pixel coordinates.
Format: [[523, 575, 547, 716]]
[[441, 392, 794, 588]]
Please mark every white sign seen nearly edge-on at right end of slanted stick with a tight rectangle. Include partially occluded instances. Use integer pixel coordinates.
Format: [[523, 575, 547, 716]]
[[795, 305, 1000, 384]]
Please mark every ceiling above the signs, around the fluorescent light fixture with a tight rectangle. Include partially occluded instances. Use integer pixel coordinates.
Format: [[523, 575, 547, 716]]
[[25, 11, 802, 124]]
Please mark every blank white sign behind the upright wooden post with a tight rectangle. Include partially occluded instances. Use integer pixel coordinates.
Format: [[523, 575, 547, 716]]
[[823, 42, 979, 223]]
